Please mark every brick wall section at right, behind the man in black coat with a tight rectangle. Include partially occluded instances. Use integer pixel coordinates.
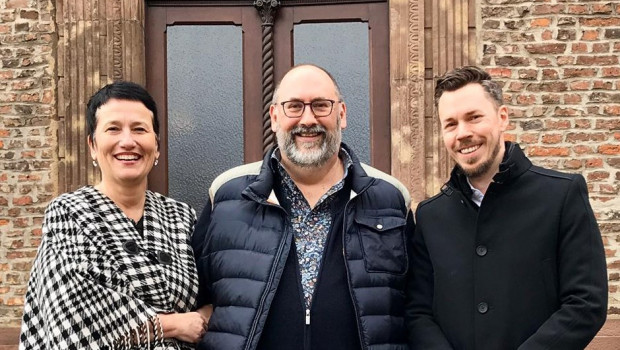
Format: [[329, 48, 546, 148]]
[[478, 0, 620, 318]]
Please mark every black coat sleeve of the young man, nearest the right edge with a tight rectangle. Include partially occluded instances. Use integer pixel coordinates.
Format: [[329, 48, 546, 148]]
[[519, 175, 607, 350]]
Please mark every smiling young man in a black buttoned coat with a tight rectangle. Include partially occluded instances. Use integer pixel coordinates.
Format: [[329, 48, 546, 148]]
[[407, 67, 607, 350]]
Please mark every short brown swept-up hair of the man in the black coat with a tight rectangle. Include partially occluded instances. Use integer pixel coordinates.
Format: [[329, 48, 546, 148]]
[[435, 66, 504, 107]]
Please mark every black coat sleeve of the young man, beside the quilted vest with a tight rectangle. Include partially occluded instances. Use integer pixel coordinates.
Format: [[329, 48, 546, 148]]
[[405, 206, 452, 350]]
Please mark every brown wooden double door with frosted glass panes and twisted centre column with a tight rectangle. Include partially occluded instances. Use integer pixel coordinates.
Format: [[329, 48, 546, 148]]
[[145, 0, 391, 211]]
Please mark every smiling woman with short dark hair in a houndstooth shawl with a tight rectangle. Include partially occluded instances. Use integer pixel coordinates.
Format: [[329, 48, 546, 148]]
[[20, 82, 209, 349]]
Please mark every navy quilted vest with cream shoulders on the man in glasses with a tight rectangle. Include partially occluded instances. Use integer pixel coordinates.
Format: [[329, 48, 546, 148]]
[[192, 144, 413, 350]]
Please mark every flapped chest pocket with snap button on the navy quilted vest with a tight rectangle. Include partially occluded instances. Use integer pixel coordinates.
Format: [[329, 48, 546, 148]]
[[355, 213, 407, 274]]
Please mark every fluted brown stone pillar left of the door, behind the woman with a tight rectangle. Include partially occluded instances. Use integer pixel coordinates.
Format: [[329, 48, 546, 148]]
[[56, 0, 146, 193]]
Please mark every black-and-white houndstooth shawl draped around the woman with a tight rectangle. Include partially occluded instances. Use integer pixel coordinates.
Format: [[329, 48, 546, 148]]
[[19, 186, 198, 350]]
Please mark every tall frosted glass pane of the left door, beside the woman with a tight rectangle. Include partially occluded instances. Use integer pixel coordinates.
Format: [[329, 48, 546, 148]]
[[166, 24, 243, 208]]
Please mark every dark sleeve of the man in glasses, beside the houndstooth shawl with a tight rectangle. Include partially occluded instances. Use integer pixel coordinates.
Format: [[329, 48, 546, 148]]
[[192, 198, 213, 308]]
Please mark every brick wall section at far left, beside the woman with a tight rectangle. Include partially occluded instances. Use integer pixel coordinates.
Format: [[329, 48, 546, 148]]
[[0, 0, 57, 327]]
